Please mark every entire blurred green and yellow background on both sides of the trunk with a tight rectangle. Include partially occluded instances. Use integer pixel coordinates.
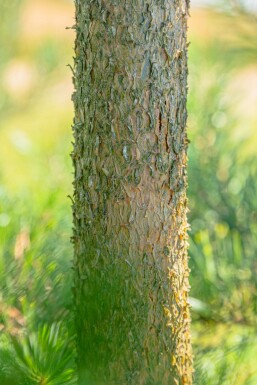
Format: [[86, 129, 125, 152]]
[[0, 0, 257, 385]]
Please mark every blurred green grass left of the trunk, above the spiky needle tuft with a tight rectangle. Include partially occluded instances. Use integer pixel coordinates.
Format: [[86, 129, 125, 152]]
[[0, 192, 72, 325]]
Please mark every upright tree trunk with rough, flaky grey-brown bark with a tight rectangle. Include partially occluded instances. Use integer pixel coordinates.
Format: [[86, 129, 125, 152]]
[[72, 0, 192, 385]]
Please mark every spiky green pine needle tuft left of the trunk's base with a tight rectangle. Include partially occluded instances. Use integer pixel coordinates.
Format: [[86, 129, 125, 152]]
[[0, 323, 76, 385]]
